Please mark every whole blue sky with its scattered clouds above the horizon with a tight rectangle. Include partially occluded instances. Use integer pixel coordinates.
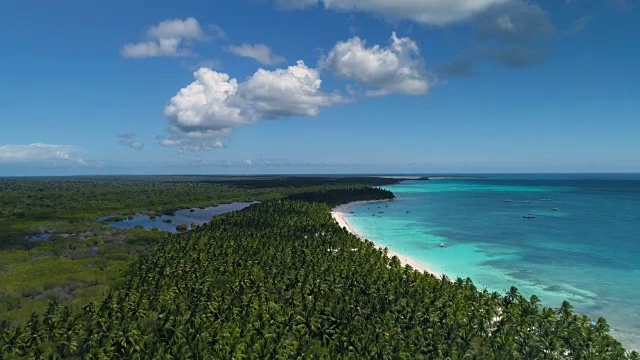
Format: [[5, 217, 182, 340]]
[[0, 0, 640, 175]]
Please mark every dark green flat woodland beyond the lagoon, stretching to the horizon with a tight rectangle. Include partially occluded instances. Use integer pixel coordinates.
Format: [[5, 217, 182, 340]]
[[0, 176, 397, 249]]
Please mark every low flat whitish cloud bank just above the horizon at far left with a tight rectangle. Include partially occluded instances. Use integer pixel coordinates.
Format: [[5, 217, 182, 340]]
[[0, 143, 84, 165]]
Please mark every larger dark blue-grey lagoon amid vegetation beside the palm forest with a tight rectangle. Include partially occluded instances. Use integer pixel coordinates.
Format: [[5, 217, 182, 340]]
[[98, 202, 257, 233]]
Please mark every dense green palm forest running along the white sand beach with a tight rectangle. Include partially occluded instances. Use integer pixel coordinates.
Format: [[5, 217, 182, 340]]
[[0, 188, 638, 359]]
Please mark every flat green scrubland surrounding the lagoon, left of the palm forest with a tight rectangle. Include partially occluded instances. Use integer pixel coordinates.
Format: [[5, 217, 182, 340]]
[[0, 176, 396, 323]]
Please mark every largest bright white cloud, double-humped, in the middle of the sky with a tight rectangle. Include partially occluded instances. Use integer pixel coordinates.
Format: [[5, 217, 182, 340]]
[[160, 61, 343, 151]]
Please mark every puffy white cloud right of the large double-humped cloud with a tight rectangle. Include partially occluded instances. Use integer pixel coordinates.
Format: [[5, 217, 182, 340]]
[[323, 32, 429, 95]]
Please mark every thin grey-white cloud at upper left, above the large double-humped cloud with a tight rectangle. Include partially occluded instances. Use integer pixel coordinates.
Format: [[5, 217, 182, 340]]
[[120, 17, 223, 59]]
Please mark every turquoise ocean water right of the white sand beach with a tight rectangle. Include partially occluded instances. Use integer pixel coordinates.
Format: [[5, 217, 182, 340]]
[[347, 174, 640, 350]]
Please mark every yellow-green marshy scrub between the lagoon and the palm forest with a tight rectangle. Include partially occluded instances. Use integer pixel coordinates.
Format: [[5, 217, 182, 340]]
[[0, 229, 167, 323]]
